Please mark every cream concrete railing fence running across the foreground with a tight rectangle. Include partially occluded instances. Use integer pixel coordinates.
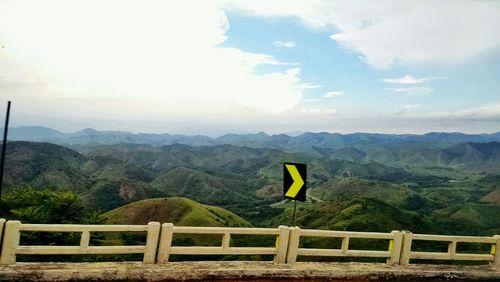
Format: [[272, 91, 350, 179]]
[[0, 219, 500, 271]]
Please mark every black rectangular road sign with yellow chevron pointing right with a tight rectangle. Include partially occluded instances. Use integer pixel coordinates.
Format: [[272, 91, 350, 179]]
[[283, 163, 307, 202]]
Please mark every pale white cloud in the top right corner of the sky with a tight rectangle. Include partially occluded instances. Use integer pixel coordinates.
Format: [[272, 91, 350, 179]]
[[227, 0, 500, 68]]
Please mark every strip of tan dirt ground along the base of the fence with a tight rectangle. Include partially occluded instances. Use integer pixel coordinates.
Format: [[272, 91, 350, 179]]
[[0, 262, 500, 281]]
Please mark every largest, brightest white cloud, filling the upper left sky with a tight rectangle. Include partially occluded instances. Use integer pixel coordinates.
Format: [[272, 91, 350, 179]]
[[0, 0, 312, 124]]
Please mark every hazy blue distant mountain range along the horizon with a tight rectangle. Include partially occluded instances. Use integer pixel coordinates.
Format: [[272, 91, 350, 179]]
[[5, 126, 500, 152]]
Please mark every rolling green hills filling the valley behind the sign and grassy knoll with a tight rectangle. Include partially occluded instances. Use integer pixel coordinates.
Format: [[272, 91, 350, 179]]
[[0, 128, 500, 240]]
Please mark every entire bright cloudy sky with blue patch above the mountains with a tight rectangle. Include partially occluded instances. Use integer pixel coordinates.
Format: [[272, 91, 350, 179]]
[[0, 0, 500, 136]]
